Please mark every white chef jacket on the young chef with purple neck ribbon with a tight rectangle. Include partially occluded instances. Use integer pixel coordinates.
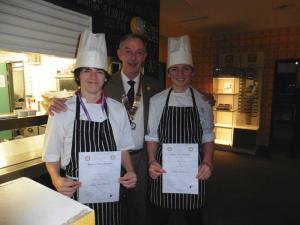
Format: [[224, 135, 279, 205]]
[[42, 96, 134, 168]]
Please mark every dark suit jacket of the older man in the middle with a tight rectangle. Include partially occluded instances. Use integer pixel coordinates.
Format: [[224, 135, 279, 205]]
[[105, 71, 162, 132]]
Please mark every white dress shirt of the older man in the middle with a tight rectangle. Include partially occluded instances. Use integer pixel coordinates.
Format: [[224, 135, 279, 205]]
[[121, 71, 145, 150]]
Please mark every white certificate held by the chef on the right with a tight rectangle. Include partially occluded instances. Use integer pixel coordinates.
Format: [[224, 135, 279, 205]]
[[162, 144, 199, 194]]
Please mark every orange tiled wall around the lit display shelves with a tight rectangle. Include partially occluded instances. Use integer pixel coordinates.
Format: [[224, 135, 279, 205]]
[[190, 25, 300, 145]]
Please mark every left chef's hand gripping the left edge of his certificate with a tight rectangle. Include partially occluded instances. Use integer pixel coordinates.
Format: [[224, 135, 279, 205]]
[[53, 177, 81, 197]]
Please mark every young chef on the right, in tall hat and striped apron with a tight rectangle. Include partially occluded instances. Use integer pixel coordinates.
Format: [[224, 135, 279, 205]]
[[146, 35, 214, 225]]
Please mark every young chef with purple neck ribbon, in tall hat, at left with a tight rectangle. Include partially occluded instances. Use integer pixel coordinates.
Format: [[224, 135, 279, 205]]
[[43, 31, 137, 225]]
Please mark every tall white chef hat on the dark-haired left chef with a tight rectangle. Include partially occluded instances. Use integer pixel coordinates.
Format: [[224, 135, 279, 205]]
[[75, 30, 108, 71]]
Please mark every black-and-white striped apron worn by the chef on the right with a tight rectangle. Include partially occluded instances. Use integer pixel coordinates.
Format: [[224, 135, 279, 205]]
[[150, 88, 205, 210]]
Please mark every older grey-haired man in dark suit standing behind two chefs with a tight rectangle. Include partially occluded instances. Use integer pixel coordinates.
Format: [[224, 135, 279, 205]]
[[106, 34, 162, 225]]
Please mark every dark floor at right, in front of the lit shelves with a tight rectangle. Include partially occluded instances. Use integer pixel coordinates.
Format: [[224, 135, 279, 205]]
[[169, 151, 300, 225]]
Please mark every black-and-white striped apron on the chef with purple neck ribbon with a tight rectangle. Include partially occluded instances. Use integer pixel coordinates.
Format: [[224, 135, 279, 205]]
[[66, 96, 121, 225]]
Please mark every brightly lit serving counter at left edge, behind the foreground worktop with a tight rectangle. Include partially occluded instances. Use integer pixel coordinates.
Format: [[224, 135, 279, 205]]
[[0, 135, 46, 183]]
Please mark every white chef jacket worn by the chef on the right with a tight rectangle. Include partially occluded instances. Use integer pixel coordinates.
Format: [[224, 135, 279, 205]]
[[145, 88, 215, 144]]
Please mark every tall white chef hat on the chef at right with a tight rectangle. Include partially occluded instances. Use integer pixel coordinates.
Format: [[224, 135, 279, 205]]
[[167, 35, 193, 68]]
